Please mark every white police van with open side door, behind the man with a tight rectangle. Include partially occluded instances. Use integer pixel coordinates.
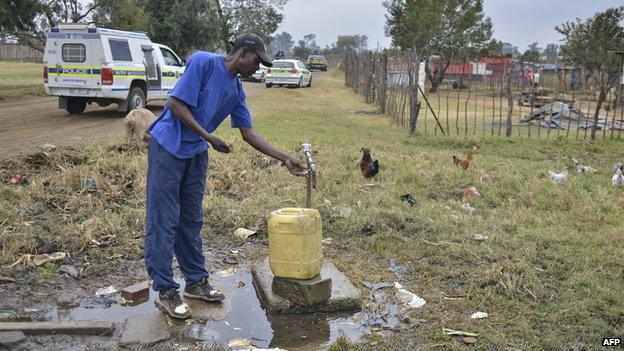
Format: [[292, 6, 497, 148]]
[[43, 24, 186, 114]]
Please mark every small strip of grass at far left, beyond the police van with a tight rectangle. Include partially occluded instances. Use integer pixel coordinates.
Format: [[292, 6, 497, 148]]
[[0, 61, 45, 101]]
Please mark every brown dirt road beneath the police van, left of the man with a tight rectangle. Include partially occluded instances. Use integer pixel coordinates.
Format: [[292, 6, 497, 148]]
[[0, 97, 164, 158]]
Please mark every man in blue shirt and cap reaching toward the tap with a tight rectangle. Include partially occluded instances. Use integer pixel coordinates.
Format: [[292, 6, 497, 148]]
[[144, 34, 305, 319]]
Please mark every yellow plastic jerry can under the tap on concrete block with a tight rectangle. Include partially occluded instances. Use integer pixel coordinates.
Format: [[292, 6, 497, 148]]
[[268, 208, 323, 279]]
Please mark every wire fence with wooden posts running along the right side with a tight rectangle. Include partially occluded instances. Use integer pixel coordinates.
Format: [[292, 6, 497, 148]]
[[340, 47, 624, 139]]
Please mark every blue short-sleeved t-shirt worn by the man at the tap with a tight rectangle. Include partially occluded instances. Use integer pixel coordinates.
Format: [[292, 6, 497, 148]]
[[149, 51, 251, 159]]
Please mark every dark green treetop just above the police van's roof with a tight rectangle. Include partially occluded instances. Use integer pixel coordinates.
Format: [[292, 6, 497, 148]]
[[93, 0, 148, 31]]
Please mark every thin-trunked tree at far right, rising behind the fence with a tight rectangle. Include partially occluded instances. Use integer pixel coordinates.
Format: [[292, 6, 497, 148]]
[[555, 7, 624, 140]]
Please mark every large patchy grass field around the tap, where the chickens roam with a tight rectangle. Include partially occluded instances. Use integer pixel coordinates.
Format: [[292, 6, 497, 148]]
[[0, 72, 624, 350]]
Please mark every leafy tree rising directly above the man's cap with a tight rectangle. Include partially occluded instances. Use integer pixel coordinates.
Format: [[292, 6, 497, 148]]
[[213, 0, 288, 51]]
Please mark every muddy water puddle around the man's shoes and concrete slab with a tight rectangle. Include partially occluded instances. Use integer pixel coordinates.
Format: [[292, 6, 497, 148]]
[[46, 267, 370, 351]]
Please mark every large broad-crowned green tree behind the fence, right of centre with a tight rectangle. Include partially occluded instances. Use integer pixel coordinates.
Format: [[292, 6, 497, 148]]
[[384, 0, 497, 92]]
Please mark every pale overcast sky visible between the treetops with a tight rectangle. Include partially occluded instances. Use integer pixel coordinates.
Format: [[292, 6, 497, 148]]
[[278, 0, 624, 51]]
